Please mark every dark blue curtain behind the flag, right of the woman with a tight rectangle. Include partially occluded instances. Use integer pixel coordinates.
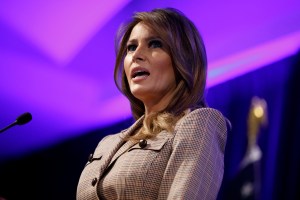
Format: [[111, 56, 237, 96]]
[[213, 50, 300, 200]]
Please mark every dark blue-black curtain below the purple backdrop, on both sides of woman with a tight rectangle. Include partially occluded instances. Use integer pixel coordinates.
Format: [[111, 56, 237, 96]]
[[0, 51, 300, 200]]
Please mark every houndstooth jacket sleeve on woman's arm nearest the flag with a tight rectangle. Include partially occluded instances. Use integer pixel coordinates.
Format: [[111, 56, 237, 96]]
[[158, 108, 227, 200]]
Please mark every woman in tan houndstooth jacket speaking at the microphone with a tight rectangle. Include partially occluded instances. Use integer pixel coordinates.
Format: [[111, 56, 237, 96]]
[[77, 8, 227, 200]]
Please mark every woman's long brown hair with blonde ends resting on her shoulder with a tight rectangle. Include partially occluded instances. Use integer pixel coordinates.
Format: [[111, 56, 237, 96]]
[[114, 8, 207, 138]]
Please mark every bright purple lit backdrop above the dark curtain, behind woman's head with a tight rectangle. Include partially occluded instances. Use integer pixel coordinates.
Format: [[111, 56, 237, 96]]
[[0, 0, 300, 160]]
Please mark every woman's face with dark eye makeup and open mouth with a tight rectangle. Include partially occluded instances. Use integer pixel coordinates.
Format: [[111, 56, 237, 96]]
[[124, 23, 176, 112]]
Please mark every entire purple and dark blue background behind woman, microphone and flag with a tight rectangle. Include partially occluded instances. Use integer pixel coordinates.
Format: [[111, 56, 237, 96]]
[[0, 0, 300, 200]]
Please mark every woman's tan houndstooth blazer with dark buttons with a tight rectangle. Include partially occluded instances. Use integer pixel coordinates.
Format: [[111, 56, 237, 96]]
[[77, 108, 227, 200]]
